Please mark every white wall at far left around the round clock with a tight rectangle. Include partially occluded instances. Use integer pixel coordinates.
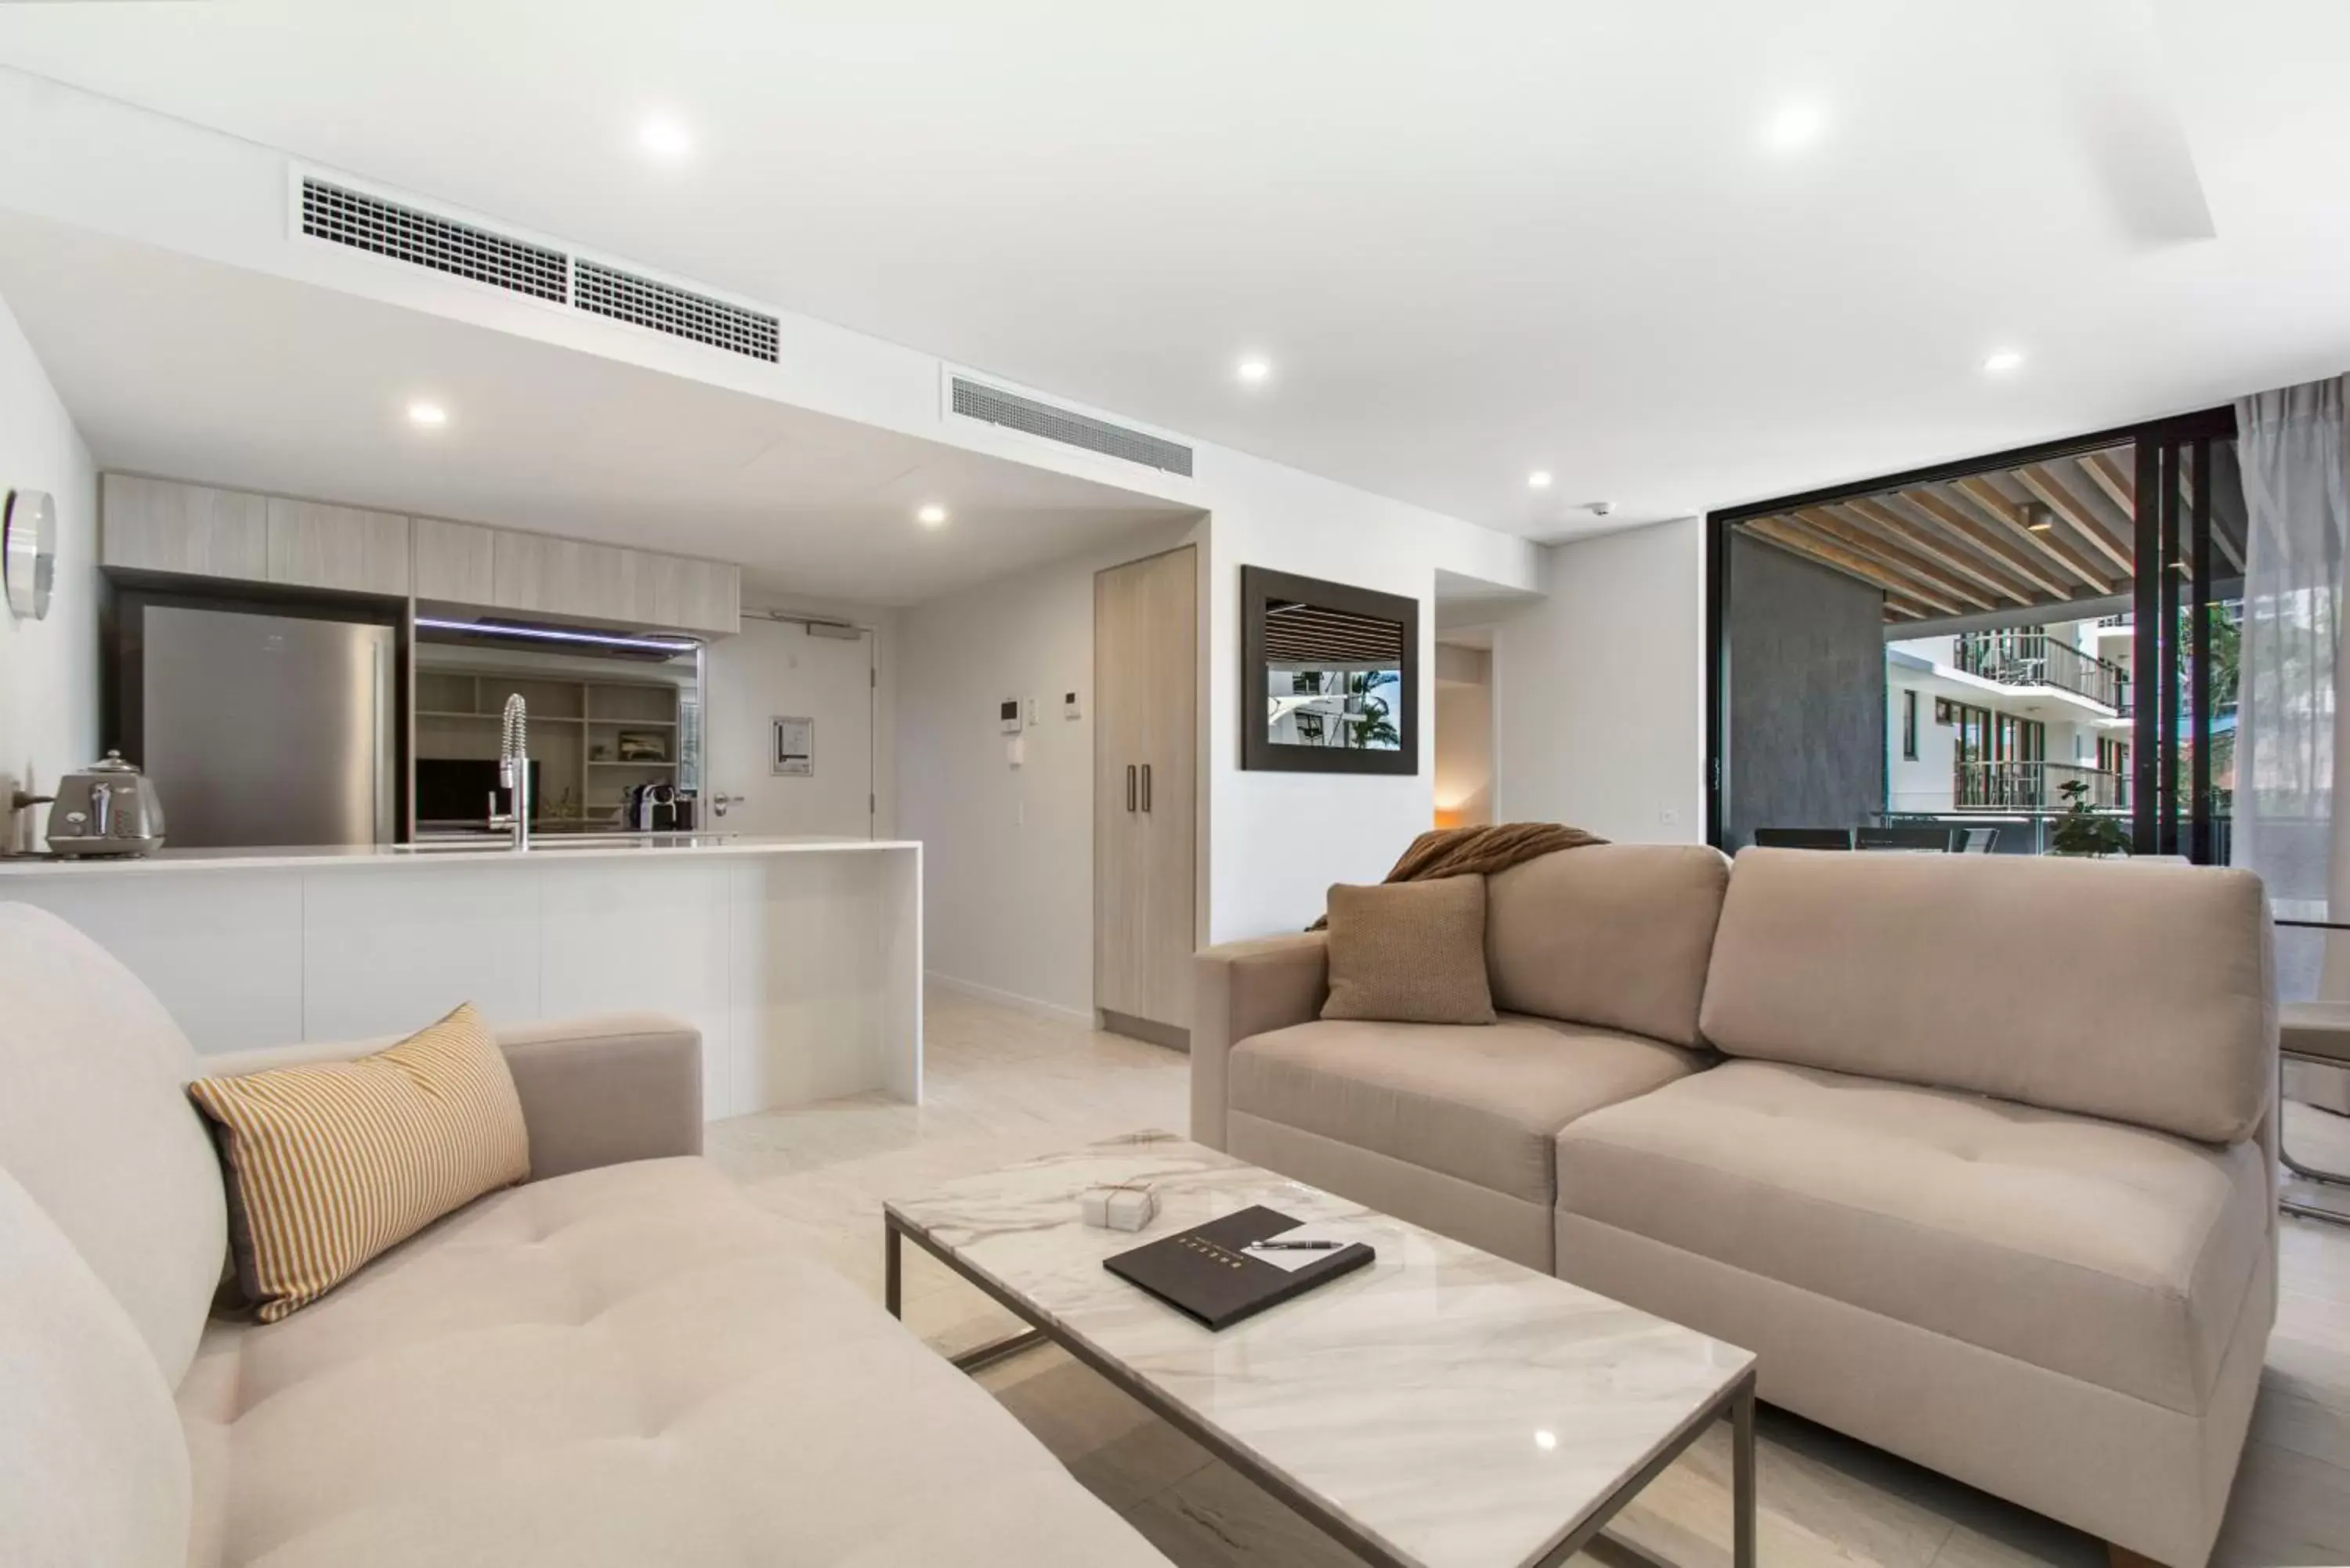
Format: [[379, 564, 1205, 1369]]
[[0, 282, 103, 849]]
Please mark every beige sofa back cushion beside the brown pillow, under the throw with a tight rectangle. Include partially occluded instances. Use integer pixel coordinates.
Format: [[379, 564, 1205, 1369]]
[[1485, 844, 1730, 1046]]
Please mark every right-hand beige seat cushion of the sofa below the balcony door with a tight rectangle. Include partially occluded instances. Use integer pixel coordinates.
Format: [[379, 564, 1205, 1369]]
[[1558, 1067, 2268, 1413]]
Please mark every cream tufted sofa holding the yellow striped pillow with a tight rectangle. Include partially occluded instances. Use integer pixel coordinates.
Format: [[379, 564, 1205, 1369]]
[[0, 905, 1166, 1568]]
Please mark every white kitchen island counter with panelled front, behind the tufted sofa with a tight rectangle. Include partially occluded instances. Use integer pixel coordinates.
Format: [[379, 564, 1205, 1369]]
[[0, 835, 921, 1117]]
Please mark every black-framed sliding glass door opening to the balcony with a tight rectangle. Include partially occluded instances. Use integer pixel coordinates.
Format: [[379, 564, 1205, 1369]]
[[1708, 409, 2244, 863]]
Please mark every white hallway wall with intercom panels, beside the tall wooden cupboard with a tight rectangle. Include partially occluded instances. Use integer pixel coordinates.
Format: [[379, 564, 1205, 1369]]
[[898, 524, 1198, 1021]]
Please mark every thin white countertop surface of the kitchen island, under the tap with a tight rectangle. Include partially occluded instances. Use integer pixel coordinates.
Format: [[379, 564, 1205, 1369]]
[[0, 833, 921, 880]]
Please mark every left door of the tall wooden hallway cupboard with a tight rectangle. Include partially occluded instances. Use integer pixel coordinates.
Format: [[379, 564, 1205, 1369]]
[[1093, 552, 1147, 1016]]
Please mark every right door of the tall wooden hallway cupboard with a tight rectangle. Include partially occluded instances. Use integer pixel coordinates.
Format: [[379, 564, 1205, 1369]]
[[1137, 547, 1198, 1030]]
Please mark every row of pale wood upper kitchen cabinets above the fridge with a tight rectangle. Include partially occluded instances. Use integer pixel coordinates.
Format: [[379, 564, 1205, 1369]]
[[99, 472, 743, 634]]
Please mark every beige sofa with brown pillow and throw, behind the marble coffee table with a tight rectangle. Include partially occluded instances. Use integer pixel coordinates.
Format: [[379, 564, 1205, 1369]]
[[1191, 847, 2277, 1568]]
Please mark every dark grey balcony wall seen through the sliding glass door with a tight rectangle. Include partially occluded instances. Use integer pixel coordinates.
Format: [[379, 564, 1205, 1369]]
[[1723, 529, 1885, 854]]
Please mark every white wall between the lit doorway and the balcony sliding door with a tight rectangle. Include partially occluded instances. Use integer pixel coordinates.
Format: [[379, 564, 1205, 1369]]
[[1492, 517, 1706, 844]]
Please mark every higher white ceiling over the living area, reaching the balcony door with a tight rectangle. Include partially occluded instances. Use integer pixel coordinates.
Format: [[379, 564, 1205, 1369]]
[[0, 0, 2350, 536]]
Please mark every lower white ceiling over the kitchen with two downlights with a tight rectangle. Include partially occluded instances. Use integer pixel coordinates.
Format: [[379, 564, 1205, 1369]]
[[0, 214, 1187, 604]]
